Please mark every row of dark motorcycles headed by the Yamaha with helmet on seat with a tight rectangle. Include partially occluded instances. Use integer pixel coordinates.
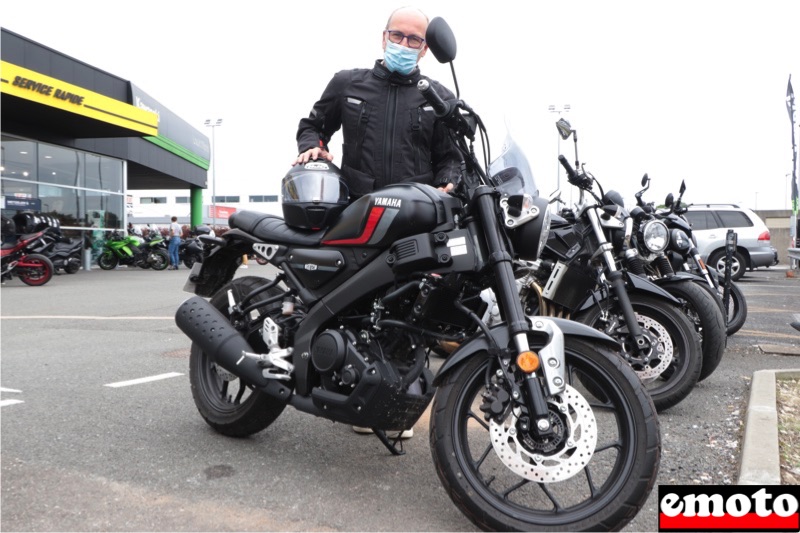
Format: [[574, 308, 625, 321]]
[[167, 18, 746, 531]]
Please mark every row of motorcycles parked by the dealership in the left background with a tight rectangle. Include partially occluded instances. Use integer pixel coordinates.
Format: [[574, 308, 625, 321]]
[[2, 212, 210, 286]]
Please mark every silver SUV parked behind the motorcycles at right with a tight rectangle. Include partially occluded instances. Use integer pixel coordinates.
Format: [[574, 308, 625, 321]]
[[684, 204, 778, 280]]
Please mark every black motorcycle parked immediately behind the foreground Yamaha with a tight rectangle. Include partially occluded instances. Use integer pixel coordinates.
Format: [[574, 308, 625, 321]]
[[517, 119, 703, 411]]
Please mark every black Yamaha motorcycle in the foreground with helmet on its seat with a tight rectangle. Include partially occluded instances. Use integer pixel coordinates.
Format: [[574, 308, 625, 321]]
[[176, 18, 660, 531]]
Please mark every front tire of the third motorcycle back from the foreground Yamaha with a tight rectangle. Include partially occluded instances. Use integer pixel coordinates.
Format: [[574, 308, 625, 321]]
[[662, 281, 728, 381]]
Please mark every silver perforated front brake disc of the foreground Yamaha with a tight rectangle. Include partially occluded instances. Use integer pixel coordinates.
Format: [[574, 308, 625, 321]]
[[489, 385, 597, 483]]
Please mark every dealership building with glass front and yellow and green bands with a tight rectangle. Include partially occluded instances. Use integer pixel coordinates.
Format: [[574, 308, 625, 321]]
[[0, 28, 210, 239]]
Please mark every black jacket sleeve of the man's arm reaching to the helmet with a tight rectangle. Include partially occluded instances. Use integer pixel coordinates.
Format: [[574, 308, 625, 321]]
[[297, 71, 347, 153]]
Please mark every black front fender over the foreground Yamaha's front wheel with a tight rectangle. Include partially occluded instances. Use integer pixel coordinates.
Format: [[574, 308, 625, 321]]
[[433, 317, 620, 386]]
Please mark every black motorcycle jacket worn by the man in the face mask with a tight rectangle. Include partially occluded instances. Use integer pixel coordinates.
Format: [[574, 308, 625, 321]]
[[297, 60, 461, 199]]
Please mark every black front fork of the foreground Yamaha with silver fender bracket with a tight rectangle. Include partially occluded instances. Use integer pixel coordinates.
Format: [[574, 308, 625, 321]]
[[475, 186, 566, 436]]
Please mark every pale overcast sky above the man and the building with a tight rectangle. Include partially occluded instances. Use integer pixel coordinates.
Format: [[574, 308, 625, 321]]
[[0, 0, 800, 209]]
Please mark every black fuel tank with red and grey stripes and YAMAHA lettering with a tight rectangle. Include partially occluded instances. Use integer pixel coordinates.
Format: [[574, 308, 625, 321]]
[[322, 183, 461, 248]]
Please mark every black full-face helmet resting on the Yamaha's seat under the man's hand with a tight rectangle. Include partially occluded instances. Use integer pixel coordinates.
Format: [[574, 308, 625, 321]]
[[281, 161, 350, 230]]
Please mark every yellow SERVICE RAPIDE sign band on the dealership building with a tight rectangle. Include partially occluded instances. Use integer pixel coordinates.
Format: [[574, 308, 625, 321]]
[[0, 61, 158, 136]]
